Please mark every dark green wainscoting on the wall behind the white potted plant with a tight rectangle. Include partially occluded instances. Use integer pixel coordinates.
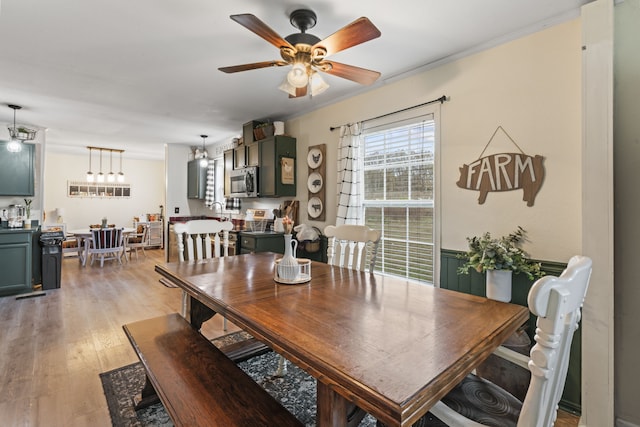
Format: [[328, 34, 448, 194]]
[[440, 249, 582, 413]]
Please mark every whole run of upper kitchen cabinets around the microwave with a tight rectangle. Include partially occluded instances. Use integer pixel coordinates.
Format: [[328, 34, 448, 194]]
[[224, 135, 296, 197]]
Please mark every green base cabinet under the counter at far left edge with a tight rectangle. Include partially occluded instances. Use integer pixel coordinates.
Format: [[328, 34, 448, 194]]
[[0, 229, 34, 296]]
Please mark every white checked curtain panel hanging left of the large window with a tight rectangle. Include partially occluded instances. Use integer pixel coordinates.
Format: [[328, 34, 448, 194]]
[[336, 123, 364, 225]]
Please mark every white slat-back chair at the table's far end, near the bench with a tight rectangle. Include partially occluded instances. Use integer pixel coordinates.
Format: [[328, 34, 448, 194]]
[[173, 219, 233, 331]]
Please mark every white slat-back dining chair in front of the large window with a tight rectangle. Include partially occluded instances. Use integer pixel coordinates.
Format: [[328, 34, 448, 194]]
[[324, 224, 380, 273]]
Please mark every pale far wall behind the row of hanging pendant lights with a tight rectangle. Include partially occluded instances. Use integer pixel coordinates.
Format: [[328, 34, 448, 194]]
[[44, 151, 165, 230]]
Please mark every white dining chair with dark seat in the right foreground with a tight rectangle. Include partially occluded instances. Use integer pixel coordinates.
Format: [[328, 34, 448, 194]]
[[378, 256, 592, 427]]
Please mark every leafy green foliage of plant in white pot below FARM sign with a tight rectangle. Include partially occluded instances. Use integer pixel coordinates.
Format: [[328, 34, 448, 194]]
[[458, 226, 545, 280]]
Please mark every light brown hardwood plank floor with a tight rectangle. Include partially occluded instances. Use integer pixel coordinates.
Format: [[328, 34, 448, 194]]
[[0, 250, 578, 427]]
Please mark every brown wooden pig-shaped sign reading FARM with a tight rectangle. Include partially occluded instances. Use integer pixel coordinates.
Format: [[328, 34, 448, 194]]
[[457, 153, 544, 206]]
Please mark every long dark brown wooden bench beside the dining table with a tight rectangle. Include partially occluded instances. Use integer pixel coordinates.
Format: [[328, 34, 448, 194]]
[[123, 313, 302, 427]]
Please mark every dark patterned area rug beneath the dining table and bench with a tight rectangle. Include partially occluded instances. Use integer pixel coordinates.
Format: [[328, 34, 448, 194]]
[[100, 333, 376, 427]]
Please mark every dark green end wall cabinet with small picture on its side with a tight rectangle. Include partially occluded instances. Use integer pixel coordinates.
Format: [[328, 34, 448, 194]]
[[257, 135, 296, 197]]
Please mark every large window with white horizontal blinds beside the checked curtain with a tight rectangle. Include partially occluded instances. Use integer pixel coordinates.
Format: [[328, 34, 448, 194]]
[[362, 115, 436, 284]]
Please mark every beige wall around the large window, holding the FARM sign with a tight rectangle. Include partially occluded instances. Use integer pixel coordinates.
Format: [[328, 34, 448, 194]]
[[287, 19, 581, 262]]
